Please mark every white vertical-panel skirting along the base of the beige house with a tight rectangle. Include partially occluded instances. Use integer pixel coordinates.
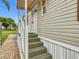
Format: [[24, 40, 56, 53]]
[[39, 36, 79, 59]]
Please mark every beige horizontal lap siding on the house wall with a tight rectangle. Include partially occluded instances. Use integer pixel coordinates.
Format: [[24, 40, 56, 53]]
[[38, 0, 79, 46]]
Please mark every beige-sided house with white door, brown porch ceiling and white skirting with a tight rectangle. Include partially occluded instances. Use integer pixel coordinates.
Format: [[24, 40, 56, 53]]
[[28, 0, 79, 59]]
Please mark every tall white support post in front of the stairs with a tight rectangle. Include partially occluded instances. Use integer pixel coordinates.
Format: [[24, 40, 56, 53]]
[[25, 0, 28, 59]]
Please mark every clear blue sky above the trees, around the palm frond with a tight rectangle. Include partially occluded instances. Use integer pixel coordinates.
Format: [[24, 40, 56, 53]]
[[0, 0, 24, 23]]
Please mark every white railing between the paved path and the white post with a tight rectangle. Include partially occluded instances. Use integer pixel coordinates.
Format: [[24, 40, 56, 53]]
[[17, 17, 28, 59]]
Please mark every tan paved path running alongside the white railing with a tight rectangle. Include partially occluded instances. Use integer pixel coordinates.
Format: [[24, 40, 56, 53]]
[[0, 34, 20, 59]]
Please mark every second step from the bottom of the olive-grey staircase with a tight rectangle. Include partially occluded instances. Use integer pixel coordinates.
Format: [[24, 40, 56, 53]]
[[29, 46, 47, 57]]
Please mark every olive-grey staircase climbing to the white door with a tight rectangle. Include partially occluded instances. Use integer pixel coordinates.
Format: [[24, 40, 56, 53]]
[[29, 33, 52, 59]]
